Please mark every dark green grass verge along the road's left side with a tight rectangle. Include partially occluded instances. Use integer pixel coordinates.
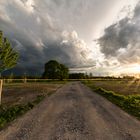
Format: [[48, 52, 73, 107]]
[[0, 95, 45, 129]]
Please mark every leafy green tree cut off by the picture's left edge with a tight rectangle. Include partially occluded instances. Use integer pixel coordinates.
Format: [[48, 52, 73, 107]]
[[0, 31, 19, 104]]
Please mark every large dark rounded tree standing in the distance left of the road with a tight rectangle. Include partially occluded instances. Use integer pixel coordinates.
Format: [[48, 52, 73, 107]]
[[42, 60, 69, 80]]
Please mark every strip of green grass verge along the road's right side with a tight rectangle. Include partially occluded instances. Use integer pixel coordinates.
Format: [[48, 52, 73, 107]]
[[83, 81, 140, 119]]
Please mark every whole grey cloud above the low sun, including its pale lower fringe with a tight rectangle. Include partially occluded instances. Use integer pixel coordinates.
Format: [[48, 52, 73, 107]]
[[98, 0, 140, 64]]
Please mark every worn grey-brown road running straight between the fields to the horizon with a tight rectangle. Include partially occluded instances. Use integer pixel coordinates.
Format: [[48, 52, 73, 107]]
[[0, 82, 140, 140]]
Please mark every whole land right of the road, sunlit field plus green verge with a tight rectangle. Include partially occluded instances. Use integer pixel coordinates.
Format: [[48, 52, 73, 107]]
[[83, 80, 140, 119]]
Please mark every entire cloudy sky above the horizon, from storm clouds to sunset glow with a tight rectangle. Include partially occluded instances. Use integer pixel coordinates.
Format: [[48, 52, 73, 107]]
[[0, 0, 140, 76]]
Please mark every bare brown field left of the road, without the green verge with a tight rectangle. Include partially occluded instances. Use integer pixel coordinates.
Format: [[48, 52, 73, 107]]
[[2, 83, 62, 105]]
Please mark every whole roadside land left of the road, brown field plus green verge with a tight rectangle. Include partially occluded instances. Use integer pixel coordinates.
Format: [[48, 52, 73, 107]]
[[0, 82, 63, 129]]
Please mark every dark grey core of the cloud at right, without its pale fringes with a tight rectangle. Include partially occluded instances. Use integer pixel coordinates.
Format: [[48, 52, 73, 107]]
[[98, 18, 133, 56]]
